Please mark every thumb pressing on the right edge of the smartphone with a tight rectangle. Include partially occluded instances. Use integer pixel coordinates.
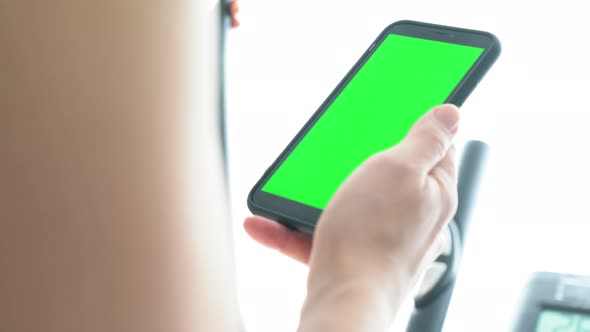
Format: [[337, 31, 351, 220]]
[[397, 104, 459, 173]]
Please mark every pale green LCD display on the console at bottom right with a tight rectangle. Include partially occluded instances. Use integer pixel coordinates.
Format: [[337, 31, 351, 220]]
[[535, 310, 590, 332]]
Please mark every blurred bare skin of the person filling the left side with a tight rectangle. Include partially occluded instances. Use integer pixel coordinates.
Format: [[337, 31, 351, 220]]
[[0, 0, 241, 332]]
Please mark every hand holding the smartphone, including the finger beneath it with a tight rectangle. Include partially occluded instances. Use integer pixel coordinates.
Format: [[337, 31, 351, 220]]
[[244, 105, 459, 331]]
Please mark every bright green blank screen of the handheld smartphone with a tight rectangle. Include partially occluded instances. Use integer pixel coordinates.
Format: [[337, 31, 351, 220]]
[[262, 34, 484, 209]]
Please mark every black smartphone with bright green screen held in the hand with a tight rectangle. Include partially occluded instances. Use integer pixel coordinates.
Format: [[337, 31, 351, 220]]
[[248, 21, 501, 234]]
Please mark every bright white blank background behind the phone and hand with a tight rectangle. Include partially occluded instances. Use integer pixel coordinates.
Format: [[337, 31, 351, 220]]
[[222, 0, 590, 332]]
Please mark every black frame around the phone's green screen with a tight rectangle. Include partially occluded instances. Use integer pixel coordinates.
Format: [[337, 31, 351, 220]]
[[247, 20, 501, 234]]
